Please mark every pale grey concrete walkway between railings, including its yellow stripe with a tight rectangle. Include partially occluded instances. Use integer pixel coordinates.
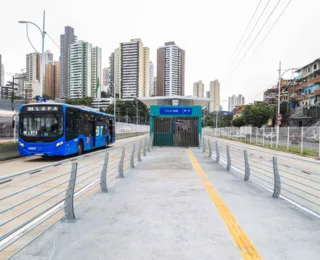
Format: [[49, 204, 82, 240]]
[[13, 148, 320, 260]]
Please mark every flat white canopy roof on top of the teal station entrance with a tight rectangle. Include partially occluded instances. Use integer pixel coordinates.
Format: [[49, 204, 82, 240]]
[[139, 96, 211, 107]]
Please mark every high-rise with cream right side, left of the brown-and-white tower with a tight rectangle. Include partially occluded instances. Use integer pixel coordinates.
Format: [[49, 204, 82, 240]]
[[120, 39, 149, 100]]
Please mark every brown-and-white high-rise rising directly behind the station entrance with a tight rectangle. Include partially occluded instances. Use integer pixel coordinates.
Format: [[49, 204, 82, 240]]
[[157, 42, 185, 96]]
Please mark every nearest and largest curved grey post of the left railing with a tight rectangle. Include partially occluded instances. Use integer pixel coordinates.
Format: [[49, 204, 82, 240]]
[[64, 162, 78, 222]]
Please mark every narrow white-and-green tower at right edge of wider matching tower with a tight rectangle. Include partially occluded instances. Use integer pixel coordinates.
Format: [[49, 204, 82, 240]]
[[91, 47, 102, 98]]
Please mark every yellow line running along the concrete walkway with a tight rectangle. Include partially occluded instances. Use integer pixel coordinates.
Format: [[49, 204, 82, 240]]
[[187, 149, 262, 260]]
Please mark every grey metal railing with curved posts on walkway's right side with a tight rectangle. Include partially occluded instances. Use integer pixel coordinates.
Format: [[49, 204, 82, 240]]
[[199, 136, 320, 218]]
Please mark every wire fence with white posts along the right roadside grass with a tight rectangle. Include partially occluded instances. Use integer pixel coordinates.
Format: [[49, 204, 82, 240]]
[[203, 126, 320, 157]]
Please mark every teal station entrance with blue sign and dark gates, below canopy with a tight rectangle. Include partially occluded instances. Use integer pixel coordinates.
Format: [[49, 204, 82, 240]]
[[150, 106, 202, 147]]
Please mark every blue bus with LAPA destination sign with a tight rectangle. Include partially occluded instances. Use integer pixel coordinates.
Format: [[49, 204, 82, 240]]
[[19, 103, 116, 157]]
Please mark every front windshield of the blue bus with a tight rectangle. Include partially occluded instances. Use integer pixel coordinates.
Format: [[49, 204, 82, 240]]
[[20, 113, 63, 137]]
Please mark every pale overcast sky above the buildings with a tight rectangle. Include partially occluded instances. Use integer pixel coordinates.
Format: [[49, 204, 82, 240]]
[[0, 0, 320, 107]]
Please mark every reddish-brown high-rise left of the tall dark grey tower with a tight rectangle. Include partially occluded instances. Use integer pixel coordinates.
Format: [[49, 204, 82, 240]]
[[44, 61, 60, 100]]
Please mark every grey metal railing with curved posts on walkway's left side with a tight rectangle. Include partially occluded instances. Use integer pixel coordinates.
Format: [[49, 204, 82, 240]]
[[0, 135, 153, 259]]
